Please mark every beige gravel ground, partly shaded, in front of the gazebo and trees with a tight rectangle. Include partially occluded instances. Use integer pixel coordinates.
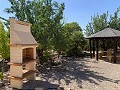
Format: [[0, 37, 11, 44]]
[[37, 58, 120, 90]]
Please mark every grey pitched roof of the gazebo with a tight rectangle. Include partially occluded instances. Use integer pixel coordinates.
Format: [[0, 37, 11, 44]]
[[87, 28, 120, 39]]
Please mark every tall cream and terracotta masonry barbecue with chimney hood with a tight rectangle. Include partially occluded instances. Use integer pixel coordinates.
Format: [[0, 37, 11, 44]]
[[9, 18, 37, 89]]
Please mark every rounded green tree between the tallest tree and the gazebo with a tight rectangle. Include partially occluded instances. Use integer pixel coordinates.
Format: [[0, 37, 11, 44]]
[[63, 22, 86, 56]]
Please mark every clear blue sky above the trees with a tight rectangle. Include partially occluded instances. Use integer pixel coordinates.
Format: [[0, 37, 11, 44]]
[[0, 0, 120, 28]]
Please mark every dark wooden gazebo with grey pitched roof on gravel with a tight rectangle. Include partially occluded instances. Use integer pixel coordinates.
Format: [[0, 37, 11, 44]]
[[87, 28, 120, 63]]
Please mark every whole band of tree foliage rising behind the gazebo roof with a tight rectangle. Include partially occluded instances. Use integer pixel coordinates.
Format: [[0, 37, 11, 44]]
[[85, 8, 120, 36]]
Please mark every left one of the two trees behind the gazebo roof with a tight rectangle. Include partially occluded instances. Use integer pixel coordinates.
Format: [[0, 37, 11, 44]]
[[85, 13, 108, 36]]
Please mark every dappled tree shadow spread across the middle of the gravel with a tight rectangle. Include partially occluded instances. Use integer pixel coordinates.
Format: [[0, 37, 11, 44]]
[[39, 58, 115, 88]]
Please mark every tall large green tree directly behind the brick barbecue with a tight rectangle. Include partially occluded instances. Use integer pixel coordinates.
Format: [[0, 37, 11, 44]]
[[5, 0, 65, 63]]
